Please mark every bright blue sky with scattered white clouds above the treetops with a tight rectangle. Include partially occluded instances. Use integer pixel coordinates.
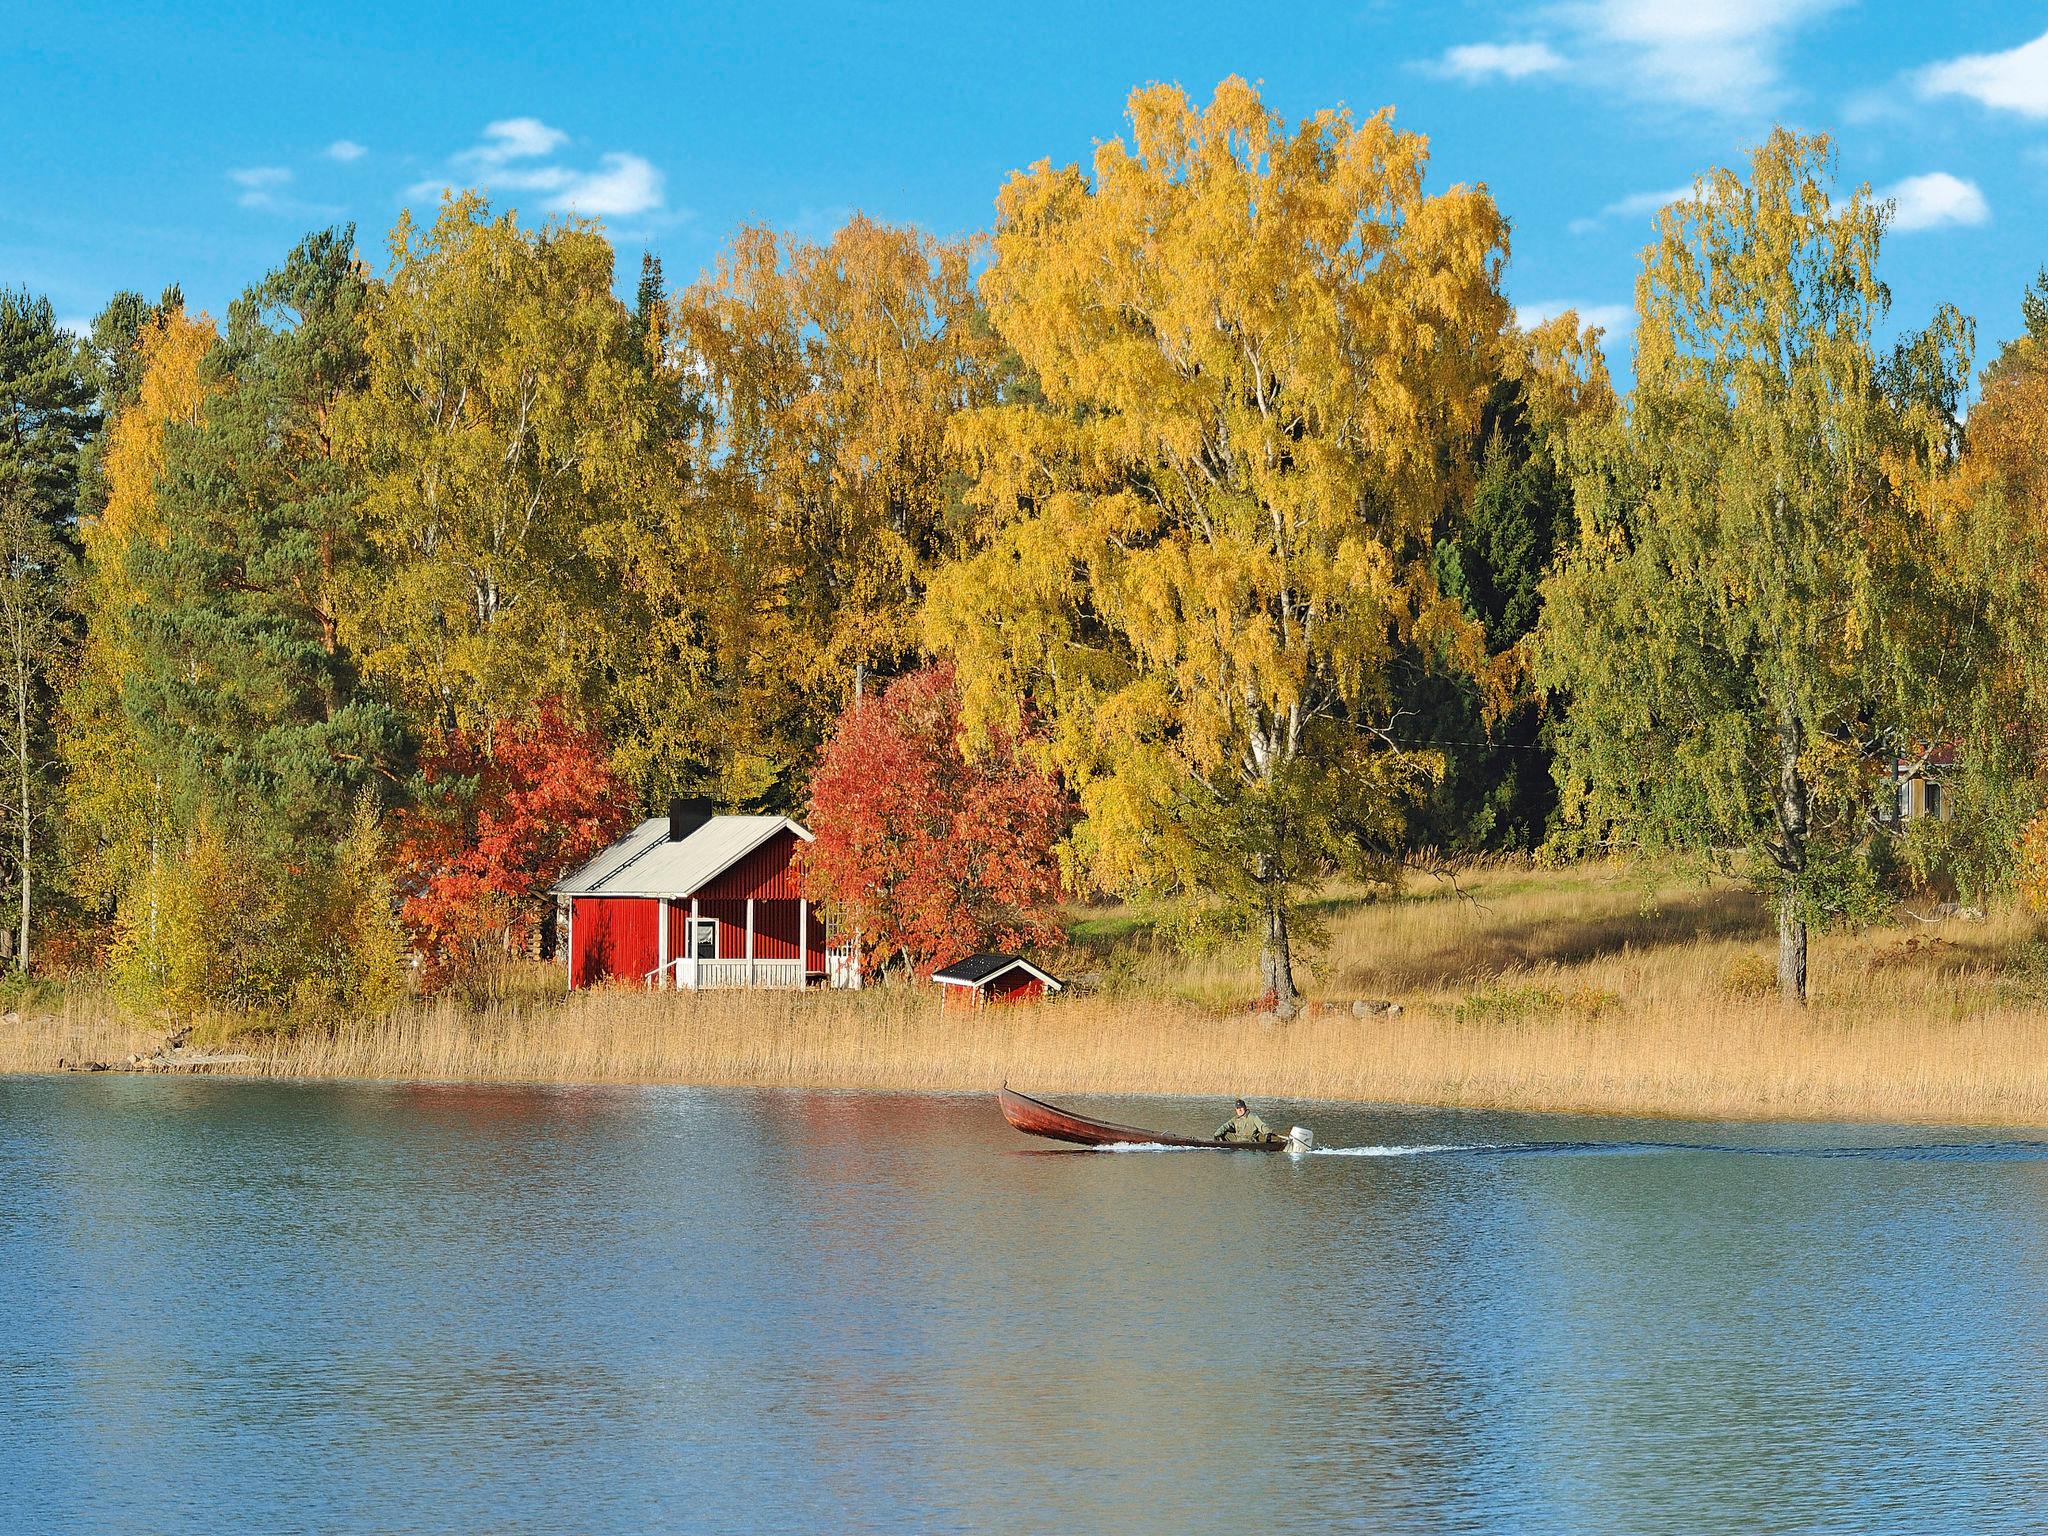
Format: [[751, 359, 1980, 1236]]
[[0, 0, 2048, 382]]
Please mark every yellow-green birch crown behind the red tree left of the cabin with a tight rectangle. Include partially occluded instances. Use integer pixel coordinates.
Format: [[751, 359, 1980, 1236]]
[[336, 193, 662, 741]]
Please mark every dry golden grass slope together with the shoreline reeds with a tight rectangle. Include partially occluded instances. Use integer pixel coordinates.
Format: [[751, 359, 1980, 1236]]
[[12, 866, 2048, 1124]]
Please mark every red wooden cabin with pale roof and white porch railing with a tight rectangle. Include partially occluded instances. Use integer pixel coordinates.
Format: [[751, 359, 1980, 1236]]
[[555, 801, 860, 989]]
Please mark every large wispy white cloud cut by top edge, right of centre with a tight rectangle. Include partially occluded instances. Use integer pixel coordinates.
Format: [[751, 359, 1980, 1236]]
[[1550, 0, 1845, 113]]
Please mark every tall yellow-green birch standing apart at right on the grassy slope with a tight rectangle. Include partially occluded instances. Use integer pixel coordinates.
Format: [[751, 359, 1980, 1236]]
[[1538, 131, 1952, 1001]]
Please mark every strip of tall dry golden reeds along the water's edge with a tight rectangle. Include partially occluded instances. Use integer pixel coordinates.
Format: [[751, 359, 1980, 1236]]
[[12, 993, 2048, 1124]]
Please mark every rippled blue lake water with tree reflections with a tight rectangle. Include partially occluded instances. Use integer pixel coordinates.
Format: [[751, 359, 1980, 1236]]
[[0, 1077, 2048, 1532]]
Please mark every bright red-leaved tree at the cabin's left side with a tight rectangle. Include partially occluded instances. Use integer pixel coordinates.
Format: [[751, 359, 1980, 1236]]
[[395, 705, 633, 983]]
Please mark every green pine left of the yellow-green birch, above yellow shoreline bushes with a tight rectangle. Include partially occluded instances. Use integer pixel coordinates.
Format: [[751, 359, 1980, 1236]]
[[123, 229, 403, 856]]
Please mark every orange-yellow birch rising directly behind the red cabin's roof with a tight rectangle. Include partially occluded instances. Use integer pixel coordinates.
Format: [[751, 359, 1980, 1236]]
[[655, 217, 995, 805]]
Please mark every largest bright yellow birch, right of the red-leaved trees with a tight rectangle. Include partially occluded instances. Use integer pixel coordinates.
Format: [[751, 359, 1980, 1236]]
[[926, 78, 1507, 1008]]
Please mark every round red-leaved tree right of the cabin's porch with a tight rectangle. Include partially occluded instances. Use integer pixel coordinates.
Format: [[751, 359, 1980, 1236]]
[[799, 668, 1067, 973]]
